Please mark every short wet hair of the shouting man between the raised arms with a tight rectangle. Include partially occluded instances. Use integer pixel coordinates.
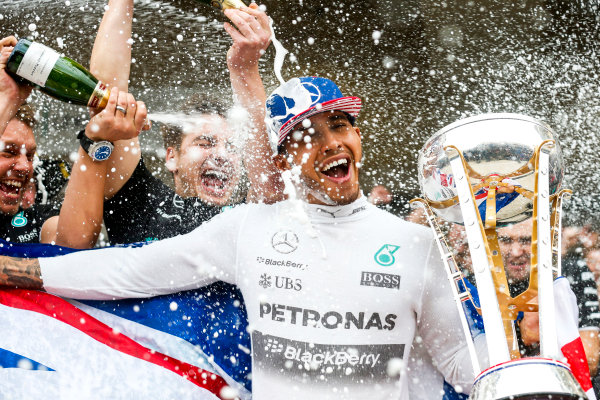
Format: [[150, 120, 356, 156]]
[[160, 94, 230, 151]]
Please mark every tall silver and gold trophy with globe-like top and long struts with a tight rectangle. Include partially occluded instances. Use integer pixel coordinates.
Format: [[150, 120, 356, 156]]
[[413, 114, 587, 400]]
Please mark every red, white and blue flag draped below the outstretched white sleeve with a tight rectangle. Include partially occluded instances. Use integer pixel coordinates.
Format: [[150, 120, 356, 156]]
[[0, 242, 250, 400]]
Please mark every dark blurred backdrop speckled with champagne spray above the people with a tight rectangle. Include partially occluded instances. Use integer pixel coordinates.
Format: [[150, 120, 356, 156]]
[[0, 0, 600, 219]]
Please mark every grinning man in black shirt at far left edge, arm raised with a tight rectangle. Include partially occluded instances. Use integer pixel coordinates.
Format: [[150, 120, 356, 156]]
[[0, 37, 58, 243]]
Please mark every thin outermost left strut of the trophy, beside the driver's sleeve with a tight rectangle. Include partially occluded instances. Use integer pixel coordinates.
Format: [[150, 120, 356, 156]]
[[410, 198, 481, 376]]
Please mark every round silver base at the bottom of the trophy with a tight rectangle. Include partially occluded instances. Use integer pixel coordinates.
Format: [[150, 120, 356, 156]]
[[469, 357, 587, 400]]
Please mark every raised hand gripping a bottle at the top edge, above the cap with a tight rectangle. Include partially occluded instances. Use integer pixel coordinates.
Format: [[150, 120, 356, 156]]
[[224, 3, 271, 72]]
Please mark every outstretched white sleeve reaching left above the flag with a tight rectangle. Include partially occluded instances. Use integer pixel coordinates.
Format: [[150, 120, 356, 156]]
[[40, 206, 247, 300]]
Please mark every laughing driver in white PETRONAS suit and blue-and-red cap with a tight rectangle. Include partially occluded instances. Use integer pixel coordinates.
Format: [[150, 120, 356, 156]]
[[0, 77, 483, 400]]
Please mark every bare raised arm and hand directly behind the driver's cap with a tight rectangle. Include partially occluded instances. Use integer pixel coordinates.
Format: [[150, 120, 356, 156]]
[[225, 3, 283, 203]]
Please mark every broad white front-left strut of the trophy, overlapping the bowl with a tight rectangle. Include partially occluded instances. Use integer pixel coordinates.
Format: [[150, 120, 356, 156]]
[[445, 146, 512, 365]]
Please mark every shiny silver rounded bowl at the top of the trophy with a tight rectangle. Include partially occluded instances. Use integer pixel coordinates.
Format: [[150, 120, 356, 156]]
[[418, 114, 563, 226]]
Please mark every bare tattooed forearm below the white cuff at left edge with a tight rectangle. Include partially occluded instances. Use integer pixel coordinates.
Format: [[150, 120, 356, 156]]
[[0, 256, 43, 289]]
